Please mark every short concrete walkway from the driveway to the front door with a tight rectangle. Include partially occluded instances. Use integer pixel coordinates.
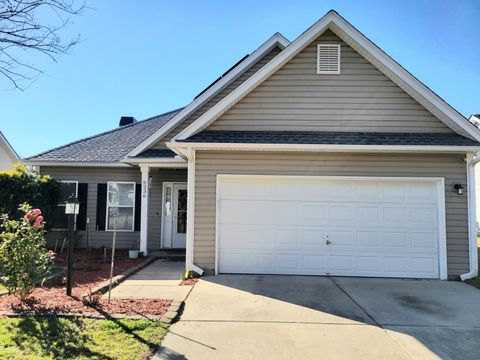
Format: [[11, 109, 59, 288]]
[[103, 260, 192, 302]]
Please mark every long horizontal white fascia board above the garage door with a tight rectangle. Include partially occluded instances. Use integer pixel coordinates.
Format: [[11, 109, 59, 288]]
[[167, 142, 480, 154]]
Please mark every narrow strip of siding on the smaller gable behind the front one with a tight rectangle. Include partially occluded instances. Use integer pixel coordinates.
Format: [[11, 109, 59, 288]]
[[152, 47, 281, 149]]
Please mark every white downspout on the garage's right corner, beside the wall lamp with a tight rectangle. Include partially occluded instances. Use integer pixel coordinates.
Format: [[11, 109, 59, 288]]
[[460, 151, 480, 281]]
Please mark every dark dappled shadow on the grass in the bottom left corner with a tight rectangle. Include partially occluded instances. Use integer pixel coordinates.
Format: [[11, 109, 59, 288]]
[[11, 316, 111, 360]]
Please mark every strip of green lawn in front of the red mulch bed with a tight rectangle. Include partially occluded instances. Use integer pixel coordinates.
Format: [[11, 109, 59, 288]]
[[0, 317, 167, 359]]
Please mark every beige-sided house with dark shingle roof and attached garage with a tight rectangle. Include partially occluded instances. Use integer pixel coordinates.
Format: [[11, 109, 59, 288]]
[[27, 11, 480, 279]]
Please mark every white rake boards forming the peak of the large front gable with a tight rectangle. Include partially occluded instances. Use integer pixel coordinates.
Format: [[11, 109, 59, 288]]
[[172, 10, 480, 142]]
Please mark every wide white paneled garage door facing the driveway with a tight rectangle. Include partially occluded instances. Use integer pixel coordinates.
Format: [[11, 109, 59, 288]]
[[217, 175, 443, 278]]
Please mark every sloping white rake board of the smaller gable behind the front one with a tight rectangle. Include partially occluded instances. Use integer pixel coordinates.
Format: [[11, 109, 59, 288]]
[[127, 33, 290, 157]]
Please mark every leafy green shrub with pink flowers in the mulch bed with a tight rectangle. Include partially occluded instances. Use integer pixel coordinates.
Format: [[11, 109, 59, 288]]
[[0, 204, 54, 301]]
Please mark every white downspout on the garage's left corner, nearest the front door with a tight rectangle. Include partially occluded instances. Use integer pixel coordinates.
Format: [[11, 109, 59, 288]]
[[185, 146, 204, 275]]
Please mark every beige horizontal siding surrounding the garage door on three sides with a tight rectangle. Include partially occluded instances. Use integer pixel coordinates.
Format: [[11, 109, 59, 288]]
[[194, 151, 469, 276]]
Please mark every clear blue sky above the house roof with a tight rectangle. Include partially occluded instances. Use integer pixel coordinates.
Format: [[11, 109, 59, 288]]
[[0, 0, 480, 157]]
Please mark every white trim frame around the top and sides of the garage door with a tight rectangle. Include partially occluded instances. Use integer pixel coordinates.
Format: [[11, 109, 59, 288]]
[[215, 174, 448, 280]]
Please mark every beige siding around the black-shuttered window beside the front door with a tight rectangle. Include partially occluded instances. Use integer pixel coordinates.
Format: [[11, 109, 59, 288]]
[[41, 166, 187, 250]]
